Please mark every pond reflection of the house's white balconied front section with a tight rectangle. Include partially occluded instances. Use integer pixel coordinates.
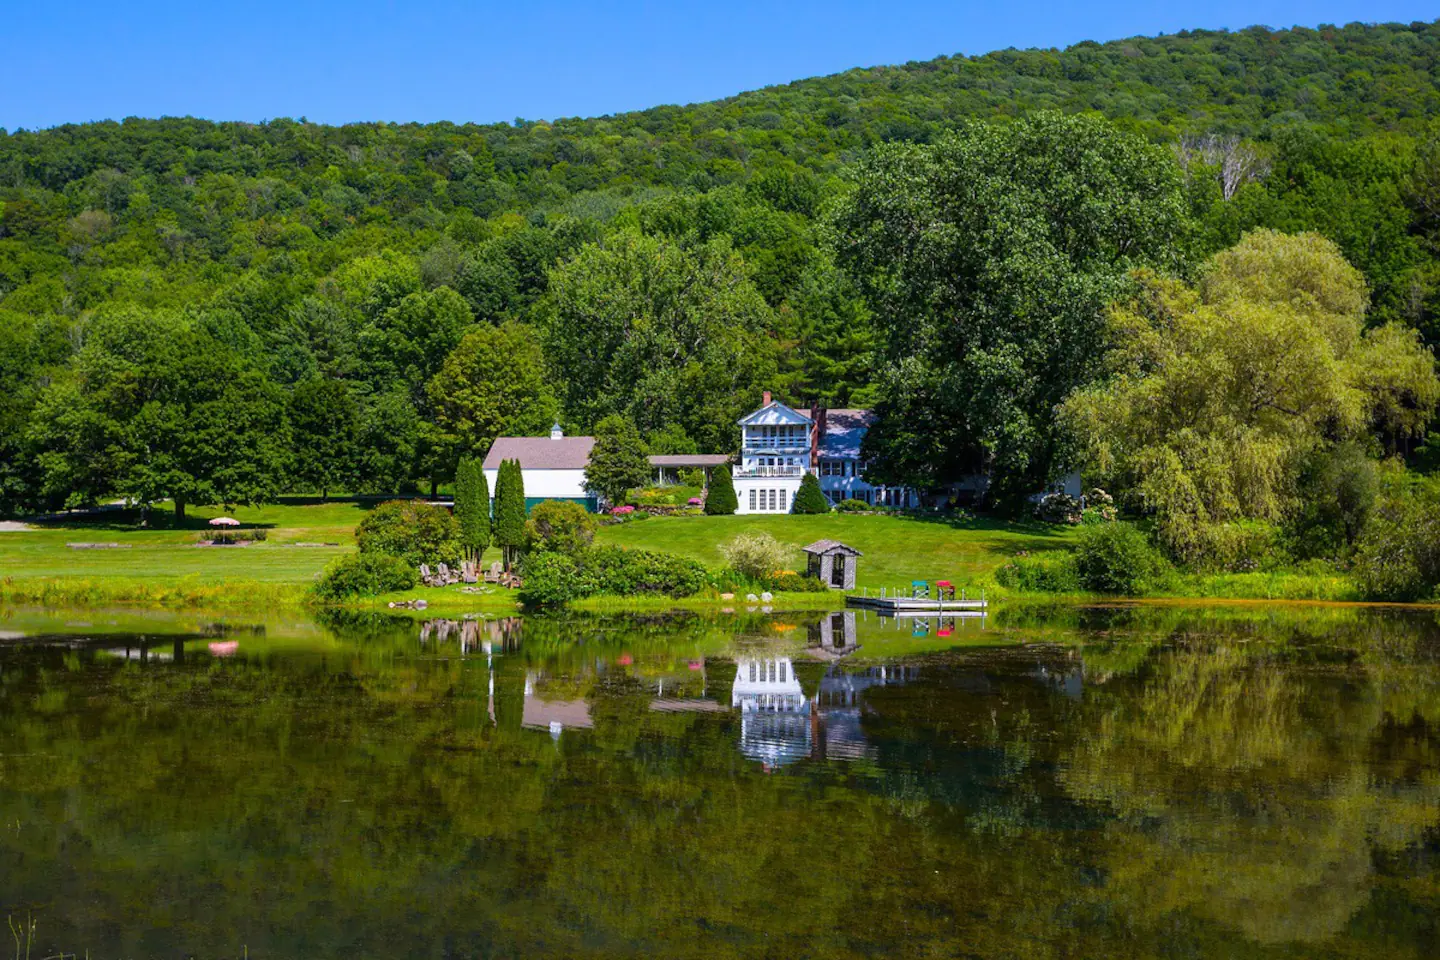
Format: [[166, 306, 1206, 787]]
[[730, 656, 812, 767]]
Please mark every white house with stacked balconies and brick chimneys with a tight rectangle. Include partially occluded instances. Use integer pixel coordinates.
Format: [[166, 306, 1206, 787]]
[[733, 390, 917, 514]]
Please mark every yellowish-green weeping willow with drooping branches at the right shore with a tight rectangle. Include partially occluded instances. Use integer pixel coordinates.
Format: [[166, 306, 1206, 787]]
[[1061, 230, 1440, 560]]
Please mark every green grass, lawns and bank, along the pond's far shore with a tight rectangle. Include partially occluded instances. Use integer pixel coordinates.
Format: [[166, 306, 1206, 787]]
[[0, 499, 1382, 613]]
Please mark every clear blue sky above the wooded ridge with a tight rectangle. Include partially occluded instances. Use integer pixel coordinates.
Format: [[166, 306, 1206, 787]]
[[0, 0, 1440, 130]]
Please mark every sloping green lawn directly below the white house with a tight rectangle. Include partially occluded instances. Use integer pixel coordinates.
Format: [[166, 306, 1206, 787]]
[[596, 514, 1076, 590]]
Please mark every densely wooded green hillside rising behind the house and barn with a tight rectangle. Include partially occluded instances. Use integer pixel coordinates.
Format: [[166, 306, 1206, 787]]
[[0, 22, 1440, 512]]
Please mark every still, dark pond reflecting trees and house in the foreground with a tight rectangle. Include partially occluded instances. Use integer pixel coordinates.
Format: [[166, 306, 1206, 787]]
[[0, 606, 1440, 959]]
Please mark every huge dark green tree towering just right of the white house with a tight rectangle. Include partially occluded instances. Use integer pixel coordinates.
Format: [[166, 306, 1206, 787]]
[[834, 114, 1185, 497]]
